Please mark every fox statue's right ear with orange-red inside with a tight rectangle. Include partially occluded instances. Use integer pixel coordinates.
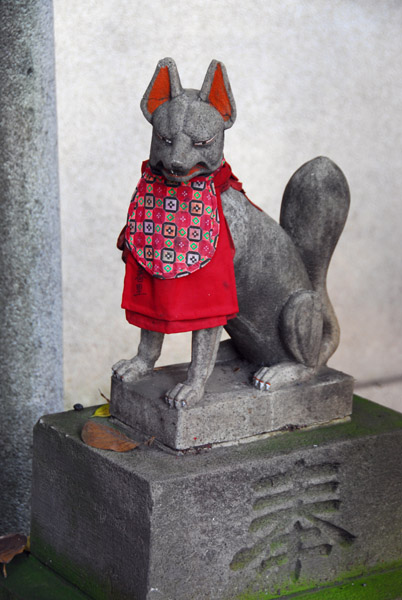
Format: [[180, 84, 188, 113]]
[[200, 60, 236, 129]]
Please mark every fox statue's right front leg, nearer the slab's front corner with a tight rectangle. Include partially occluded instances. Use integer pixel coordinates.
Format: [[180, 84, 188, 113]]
[[165, 327, 223, 408]]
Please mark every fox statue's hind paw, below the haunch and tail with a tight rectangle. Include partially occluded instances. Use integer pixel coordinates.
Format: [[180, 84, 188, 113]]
[[253, 362, 315, 391]]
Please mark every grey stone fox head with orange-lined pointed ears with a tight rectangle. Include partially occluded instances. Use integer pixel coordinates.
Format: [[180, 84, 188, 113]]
[[141, 58, 236, 182]]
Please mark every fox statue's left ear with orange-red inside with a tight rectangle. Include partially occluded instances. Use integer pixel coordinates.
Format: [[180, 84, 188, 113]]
[[141, 58, 183, 123]]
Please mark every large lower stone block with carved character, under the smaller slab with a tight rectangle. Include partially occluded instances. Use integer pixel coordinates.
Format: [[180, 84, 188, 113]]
[[31, 397, 402, 600]]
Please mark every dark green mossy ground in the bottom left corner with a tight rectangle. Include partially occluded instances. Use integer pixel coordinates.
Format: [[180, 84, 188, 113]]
[[0, 554, 89, 600]]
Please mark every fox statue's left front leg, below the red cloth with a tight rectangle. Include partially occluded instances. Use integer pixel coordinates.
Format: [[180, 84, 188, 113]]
[[112, 329, 164, 383]]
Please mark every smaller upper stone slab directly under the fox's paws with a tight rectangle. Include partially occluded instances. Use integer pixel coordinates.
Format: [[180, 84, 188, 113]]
[[110, 359, 354, 450]]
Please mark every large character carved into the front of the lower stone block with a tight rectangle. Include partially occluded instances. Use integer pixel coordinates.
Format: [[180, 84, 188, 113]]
[[230, 460, 355, 580]]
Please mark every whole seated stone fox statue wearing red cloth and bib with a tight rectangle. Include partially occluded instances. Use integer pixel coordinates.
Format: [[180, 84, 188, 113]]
[[113, 58, 349, 408]]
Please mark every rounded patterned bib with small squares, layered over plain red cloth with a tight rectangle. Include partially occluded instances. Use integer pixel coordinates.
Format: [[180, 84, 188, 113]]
[[125, 161, 224, 279]]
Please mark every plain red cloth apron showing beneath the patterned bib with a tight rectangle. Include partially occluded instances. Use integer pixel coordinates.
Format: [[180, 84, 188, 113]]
[[122, 163, 241, 333]]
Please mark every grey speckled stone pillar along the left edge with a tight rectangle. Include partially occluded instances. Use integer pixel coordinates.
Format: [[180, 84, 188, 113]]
[[0, 0, 63, 534]]
